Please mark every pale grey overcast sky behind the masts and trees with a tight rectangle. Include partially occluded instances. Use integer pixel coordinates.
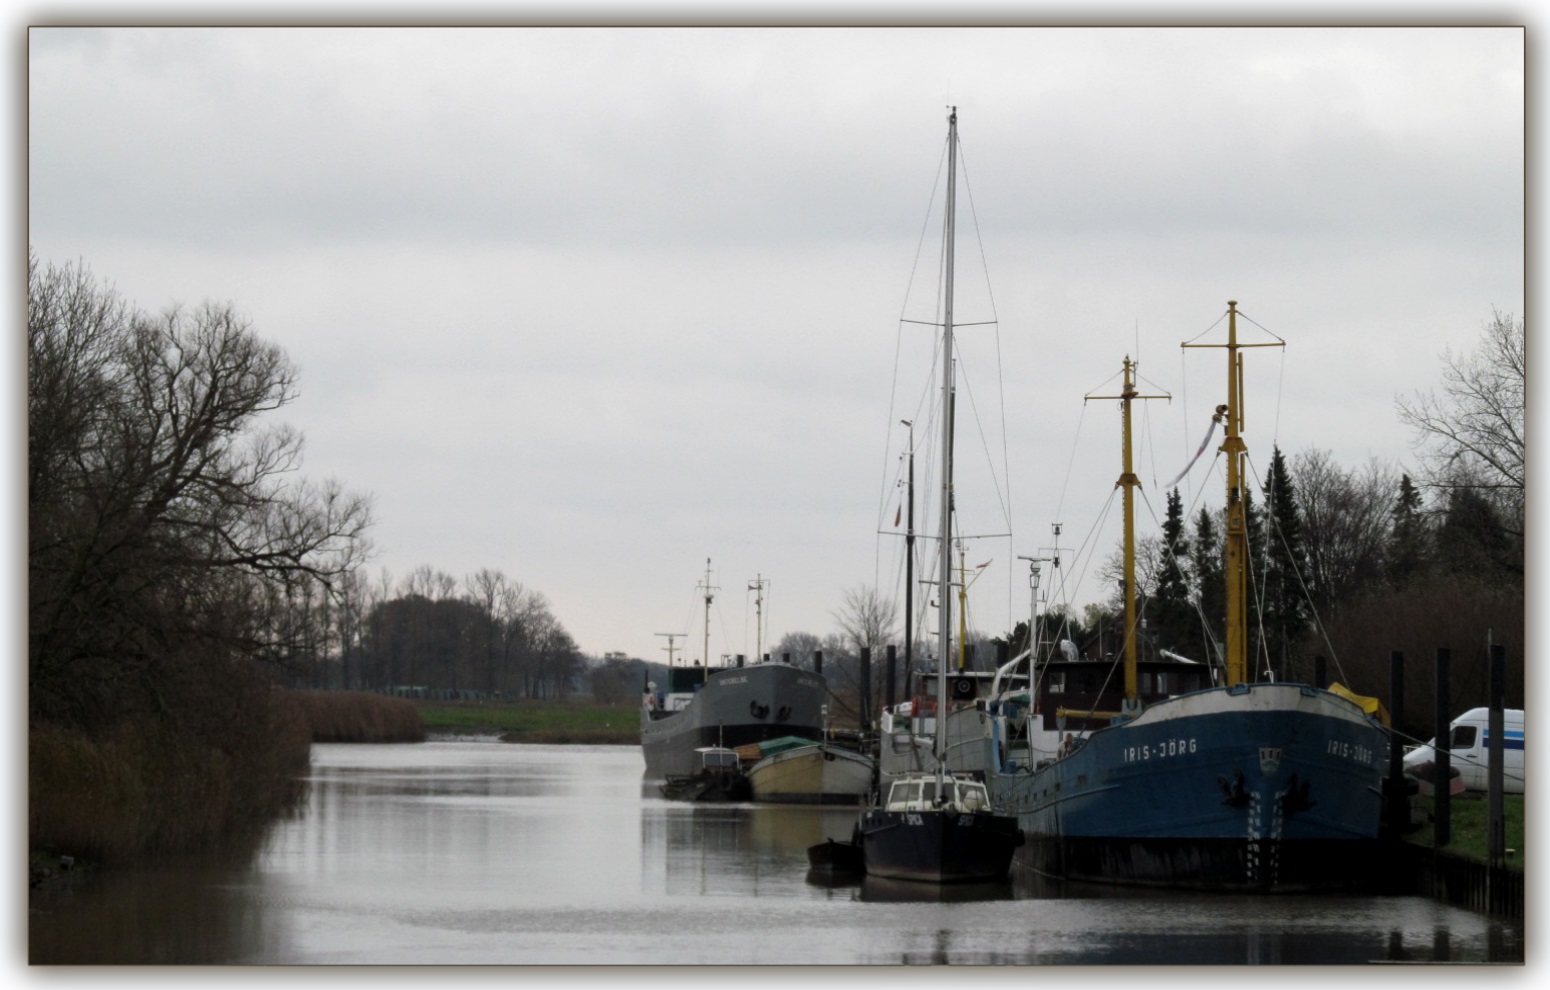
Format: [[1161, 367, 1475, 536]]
[[26, 19, 1525, 660]]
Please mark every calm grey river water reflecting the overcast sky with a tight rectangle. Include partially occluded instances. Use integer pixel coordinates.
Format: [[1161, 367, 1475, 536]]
[[29, 741, 1524, 965]]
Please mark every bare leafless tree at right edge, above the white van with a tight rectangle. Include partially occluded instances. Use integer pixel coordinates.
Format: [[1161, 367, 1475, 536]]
[[1398, 310, 1527, 536]]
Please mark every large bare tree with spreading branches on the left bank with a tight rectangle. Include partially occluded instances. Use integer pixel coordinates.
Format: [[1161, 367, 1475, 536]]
[[28, 257, 370, 725]]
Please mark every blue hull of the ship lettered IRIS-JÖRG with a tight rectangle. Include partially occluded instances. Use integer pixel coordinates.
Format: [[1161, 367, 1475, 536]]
[[986, 683, 1387, 889]]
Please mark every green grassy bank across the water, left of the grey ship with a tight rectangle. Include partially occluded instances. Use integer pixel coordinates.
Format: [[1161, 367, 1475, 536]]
[[419, 700, 640, 745]]
